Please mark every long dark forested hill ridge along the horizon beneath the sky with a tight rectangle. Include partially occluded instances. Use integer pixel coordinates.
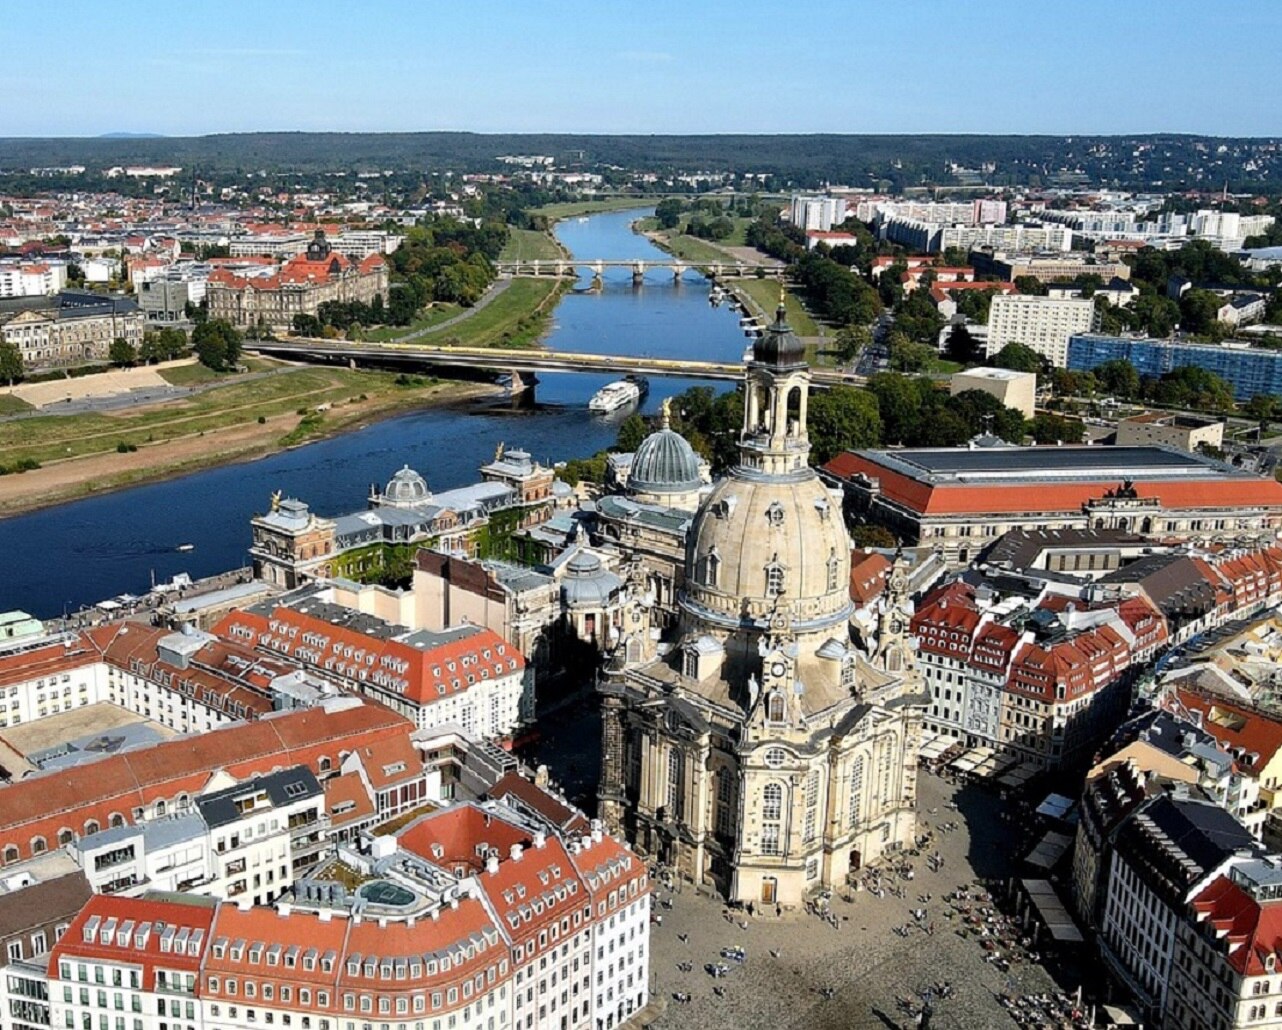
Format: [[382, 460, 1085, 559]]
[[0, 132, 1282, 191]]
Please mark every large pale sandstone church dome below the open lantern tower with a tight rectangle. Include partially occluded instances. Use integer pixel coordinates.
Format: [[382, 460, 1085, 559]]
[[682, 469, 850, 635]]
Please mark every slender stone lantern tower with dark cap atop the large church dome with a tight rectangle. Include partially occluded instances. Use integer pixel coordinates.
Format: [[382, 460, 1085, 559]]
[[738, 289, 810, 477]]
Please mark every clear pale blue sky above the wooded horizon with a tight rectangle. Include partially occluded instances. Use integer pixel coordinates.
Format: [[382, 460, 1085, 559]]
[[0, 0, 1282, 136]]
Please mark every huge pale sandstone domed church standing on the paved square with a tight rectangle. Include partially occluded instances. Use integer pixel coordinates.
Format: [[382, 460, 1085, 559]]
[[600, 309, 928, 906]]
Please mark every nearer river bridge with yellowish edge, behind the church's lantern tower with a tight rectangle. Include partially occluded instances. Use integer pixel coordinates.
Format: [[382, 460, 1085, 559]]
[[244, 339, 865, 390]]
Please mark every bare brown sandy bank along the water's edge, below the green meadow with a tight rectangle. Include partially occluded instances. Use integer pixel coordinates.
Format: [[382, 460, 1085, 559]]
[[0, 373, 503, 518]]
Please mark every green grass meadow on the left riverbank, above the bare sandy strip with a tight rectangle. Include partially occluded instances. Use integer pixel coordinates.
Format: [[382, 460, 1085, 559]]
[[0, 368, 397, 462]]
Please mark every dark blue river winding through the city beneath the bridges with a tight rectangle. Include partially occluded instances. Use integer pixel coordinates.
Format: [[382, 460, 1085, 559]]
[[0, 210, 745, 618]]
